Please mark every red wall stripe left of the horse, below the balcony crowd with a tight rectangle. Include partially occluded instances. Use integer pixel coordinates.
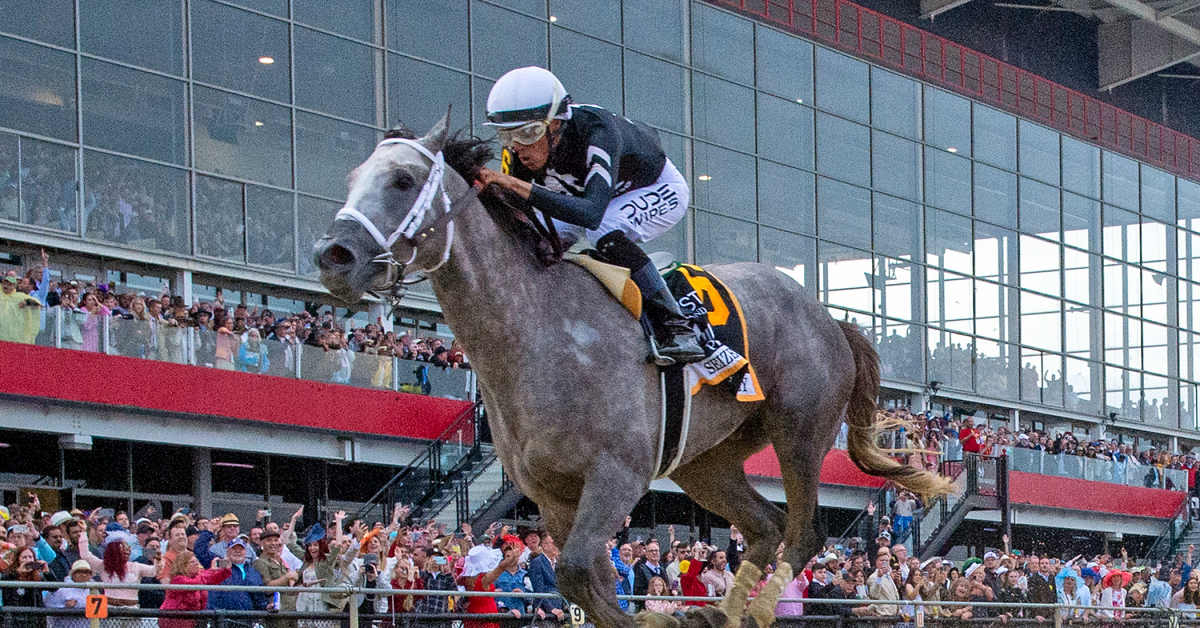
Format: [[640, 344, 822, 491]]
[[0, 342, 470, 438]]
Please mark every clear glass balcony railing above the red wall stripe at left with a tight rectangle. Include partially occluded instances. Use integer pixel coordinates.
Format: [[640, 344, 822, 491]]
[[18, 306, 475, 400]]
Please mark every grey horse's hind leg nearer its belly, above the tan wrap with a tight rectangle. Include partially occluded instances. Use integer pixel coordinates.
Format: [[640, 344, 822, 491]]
[[671, 441, 787, 568]]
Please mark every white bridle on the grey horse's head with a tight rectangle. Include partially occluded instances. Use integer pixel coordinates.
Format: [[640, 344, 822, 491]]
[[334, 137, 454, 287]]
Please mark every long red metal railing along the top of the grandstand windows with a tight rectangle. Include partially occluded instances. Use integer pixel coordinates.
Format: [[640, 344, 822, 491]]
[[708, 0, 1200, 179]]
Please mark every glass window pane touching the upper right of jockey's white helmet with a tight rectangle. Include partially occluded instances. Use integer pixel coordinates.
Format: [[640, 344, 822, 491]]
[[550, 28, 622, 113]]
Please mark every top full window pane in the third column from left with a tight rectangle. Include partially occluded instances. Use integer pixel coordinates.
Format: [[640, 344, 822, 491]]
[[190, 0, 292, 102]]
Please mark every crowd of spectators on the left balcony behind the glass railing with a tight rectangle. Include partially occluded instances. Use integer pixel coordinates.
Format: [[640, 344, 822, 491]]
[[0, 252, 470, 393]]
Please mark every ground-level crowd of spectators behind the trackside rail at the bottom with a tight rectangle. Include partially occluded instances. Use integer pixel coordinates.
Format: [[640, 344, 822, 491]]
[[7, 494, 1200, 628]]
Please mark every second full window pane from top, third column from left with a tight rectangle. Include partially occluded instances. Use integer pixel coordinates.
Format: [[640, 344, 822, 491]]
[[193, 85, 292, 187]]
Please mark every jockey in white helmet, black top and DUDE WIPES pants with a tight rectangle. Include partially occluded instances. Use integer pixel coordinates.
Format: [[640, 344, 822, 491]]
[[479, 66, 704, 364]]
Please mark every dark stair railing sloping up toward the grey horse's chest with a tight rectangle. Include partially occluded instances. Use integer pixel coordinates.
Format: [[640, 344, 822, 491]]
[[355, 402, 484, 521]]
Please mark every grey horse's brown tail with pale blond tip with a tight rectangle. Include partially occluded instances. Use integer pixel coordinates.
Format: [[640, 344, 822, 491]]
[[838, 321, 952, 498]]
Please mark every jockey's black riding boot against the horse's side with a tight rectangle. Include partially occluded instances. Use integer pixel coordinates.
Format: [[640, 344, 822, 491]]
[[596, 231, 704, 364]]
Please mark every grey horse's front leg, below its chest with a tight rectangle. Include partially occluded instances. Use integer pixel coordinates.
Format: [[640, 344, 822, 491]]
[[557, 456, 648, 628]]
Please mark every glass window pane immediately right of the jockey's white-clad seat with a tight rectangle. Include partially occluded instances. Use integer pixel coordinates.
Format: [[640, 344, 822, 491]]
[[691, 142, 756, 220]]
